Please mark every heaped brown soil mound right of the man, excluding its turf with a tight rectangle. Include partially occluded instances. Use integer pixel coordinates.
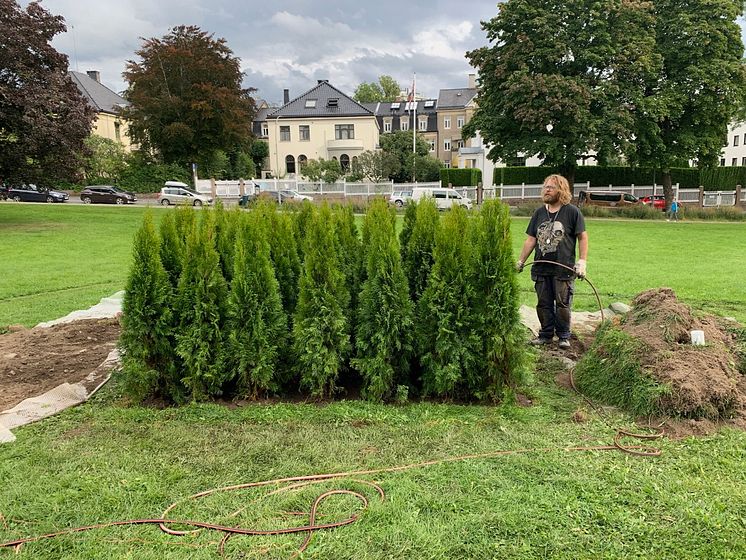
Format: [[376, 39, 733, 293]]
[[619, 288, 746, 419]]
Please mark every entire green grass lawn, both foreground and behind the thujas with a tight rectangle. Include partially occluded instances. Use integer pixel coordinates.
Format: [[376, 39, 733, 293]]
[[0, 204, 746, 560]]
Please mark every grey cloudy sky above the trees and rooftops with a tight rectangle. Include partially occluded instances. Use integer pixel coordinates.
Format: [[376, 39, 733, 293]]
[[33, 0, 497, 103]]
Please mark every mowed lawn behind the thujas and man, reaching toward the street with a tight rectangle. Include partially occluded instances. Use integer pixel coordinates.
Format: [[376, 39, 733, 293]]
[[0, 203, 746, 327]]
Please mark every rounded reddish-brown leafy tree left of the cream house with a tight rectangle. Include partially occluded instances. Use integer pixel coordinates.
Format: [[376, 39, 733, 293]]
[[124, 25, 256, 164]]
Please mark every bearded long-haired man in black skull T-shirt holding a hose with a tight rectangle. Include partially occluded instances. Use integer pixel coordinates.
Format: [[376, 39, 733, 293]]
[[516, 175, 588, 349]]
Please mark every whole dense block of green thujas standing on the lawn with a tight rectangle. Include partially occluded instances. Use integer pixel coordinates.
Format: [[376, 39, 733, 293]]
[[120, 200, 525, 403]]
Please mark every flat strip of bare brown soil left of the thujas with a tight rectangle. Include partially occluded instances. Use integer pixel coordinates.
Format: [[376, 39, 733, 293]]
[[0, 319, 119, 410]]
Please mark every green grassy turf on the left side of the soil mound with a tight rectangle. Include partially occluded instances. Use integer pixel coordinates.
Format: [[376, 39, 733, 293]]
[[575, 322, 670, 416]]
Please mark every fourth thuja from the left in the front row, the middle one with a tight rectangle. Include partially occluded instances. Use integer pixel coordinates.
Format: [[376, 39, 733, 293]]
[[293, 205, 350, 397]]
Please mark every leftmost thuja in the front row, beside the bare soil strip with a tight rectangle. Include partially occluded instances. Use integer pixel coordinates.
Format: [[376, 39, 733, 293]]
[[119, 213, 175, 400]]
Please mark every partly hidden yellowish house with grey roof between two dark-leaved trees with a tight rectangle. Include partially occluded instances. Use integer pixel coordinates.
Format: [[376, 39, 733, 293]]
[[68, 70, 132, 151]]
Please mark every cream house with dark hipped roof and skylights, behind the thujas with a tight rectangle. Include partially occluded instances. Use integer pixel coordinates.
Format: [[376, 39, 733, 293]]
[[264, 80, 379, 177]]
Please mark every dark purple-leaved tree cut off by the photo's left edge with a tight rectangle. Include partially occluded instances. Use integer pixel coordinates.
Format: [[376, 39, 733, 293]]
[[0, 0, 94, 185]]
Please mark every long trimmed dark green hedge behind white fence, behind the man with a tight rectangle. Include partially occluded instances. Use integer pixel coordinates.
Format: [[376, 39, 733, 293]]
[[492, 165, 746, 191]]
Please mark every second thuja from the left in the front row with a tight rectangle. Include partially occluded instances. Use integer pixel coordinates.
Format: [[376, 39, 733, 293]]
[[176, 210, 228, 400]]
